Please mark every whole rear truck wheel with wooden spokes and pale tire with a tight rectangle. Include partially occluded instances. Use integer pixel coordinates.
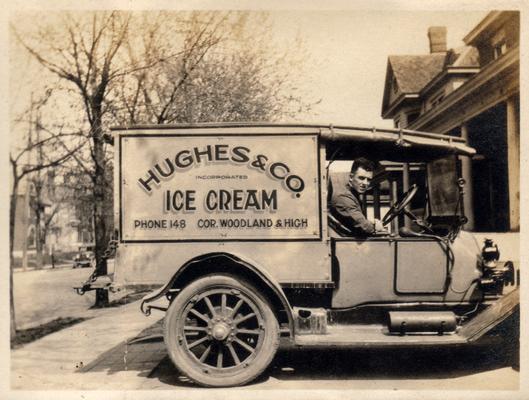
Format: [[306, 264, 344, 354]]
[[164, 275, 279, 387]]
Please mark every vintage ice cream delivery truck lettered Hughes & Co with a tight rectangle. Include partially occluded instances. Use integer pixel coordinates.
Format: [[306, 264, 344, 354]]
[[79, 124, 519, 387]]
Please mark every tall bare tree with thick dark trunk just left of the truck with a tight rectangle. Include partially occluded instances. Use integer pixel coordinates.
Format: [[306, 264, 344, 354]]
[[15, 12, 142, 304]]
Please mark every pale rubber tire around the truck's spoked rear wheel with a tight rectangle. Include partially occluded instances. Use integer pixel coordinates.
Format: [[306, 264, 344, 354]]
[[164, 274, 279, 387]]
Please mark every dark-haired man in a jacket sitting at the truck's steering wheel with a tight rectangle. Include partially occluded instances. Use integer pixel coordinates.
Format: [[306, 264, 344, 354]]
[[331, 158, 386, 236]]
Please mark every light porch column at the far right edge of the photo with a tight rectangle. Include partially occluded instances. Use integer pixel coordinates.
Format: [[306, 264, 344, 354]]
[[507, 96, 520, 231]]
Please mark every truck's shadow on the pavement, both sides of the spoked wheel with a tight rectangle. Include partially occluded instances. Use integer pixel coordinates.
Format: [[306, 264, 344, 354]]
[[80, 322, 519, 387]]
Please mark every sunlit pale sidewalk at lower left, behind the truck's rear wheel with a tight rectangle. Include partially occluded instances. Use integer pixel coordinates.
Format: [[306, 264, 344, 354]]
[[11, 301, 163, 390]]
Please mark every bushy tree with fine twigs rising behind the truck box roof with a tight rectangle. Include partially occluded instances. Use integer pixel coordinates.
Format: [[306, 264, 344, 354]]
[[112, 13, 316, 124]]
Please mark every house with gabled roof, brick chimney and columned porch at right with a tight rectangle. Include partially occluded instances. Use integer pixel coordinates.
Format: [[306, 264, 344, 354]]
[[381, 11, 520, 232]]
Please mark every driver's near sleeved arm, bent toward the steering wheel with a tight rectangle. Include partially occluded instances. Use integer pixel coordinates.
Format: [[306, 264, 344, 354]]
[[331, 193, 375, 235]]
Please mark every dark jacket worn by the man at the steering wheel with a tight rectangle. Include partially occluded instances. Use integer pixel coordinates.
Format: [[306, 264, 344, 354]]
[[331, 185, 375, 236]]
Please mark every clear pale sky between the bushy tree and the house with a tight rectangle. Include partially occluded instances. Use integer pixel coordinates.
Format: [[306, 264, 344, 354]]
[[270, 10, 487, 127]]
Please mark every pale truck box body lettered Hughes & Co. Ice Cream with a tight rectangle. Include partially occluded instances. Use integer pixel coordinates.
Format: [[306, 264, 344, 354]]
[[114, 127, 331, 286]]
